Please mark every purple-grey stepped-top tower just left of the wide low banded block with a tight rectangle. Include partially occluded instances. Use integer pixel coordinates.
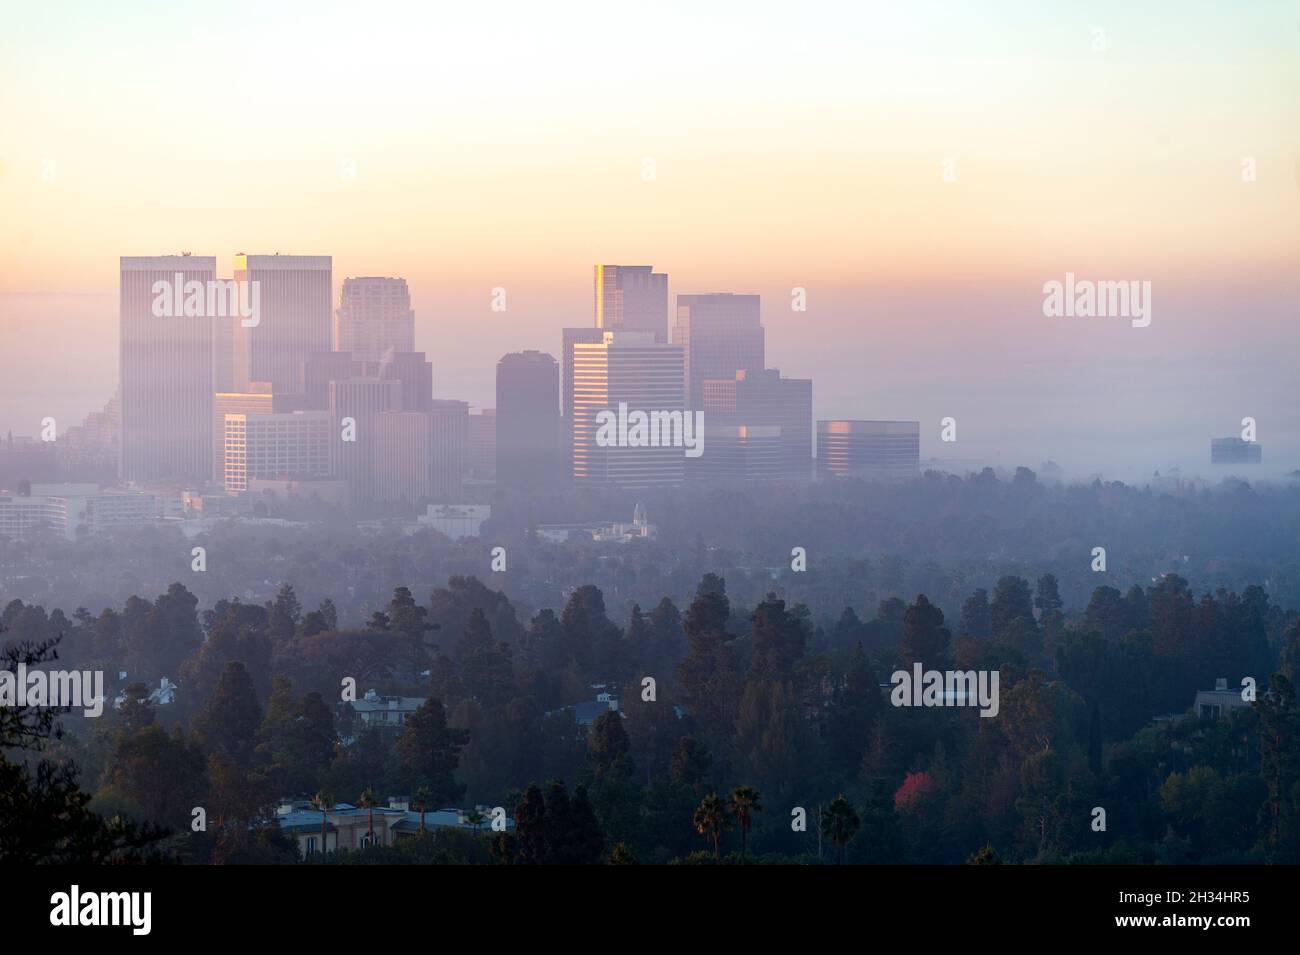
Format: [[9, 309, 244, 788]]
[[703, 368, 813, 481]]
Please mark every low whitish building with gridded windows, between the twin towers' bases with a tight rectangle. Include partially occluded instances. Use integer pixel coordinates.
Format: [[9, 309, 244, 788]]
[[224, 411, 334, 492]]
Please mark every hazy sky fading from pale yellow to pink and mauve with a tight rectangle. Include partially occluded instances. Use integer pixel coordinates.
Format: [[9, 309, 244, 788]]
[[0, 0, 1300, 478]]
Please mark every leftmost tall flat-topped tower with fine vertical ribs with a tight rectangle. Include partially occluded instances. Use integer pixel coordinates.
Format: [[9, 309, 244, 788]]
[[118, 255, 217, 482]]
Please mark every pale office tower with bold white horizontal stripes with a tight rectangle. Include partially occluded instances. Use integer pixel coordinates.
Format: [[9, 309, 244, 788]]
[[568, 331, 686, 487]]
